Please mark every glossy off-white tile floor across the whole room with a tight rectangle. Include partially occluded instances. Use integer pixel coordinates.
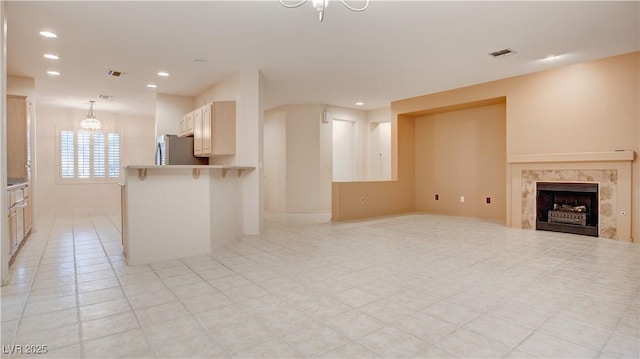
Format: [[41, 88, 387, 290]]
[[1, 212, 640, 358]]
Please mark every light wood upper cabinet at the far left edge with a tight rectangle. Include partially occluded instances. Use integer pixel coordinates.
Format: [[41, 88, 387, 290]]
[[7, 95, 30, 181]]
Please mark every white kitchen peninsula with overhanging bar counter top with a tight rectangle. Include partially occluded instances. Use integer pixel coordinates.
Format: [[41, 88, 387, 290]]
[[121, 165, 255, 265]]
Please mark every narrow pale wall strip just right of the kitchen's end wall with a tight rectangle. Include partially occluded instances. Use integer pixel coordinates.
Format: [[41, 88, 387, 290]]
[[264, 111, 287, 212]]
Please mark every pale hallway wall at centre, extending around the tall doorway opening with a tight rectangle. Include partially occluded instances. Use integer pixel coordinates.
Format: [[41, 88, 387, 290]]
[[265, 104, 369, 213]]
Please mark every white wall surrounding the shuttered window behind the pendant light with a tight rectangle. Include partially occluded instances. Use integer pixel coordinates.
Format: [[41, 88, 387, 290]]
[[34, 106, 155, 214]]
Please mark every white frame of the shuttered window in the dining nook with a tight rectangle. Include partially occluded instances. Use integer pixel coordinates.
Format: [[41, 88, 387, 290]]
[[55, 126, 124, 184]]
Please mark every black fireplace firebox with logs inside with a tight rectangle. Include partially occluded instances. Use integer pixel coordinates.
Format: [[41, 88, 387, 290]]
[[536, 182, 598, 237]]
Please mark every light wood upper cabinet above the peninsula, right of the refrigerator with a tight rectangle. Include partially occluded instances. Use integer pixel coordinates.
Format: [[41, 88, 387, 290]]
[[194, 101, 236, 156]]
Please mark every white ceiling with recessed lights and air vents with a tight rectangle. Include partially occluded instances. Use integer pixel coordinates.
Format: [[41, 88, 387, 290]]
[[7, 0, 640, 115]]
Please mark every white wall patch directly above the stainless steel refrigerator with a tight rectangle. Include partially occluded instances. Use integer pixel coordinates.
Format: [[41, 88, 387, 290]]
[[155, 93, 196, 136]]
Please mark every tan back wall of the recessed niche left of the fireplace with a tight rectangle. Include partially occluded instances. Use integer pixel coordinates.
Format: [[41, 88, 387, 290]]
[[415, 104, 507, 223]]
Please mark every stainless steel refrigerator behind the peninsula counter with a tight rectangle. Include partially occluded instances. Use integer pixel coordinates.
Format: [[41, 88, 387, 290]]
[[156, 135, 209, 165]]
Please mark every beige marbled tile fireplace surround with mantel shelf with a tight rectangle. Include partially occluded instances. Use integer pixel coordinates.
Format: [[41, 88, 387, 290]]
[[509, 151, 634, 241]]
